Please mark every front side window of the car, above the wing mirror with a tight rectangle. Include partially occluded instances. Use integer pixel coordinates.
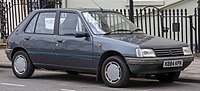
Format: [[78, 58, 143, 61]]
[[59, 13, 85, 35]]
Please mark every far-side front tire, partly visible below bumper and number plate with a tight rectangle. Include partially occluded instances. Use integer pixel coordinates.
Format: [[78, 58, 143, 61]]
[[156, 72, 180, 83]]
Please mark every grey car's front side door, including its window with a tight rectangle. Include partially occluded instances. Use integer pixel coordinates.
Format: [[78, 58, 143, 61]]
[[55, 12, 94, 68]]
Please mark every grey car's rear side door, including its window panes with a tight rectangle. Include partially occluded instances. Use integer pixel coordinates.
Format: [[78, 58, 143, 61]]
[[24, 12, 56, 65]]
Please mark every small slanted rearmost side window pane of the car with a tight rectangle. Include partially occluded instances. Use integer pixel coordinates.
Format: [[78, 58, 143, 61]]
[[25, 14, 38, 33]]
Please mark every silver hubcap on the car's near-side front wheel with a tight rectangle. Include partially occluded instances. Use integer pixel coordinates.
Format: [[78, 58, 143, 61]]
[[105, 61, 122, 83]]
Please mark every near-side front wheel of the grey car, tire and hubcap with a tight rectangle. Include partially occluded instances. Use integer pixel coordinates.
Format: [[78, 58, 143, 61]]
[[101, 56, 130, 88]]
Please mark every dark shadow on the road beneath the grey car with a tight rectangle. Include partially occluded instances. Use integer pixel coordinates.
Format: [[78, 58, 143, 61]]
[[31, 73, 189, 88]]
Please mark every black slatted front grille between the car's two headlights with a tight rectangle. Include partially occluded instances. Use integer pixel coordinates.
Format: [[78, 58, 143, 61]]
[[154, 48, 184, 57]]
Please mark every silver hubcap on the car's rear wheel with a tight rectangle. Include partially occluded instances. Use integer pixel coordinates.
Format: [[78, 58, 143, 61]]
[[14, 55, 27, 74]]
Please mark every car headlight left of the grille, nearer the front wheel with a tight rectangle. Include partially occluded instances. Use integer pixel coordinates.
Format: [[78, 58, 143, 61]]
[[136, 48, 156, 57]]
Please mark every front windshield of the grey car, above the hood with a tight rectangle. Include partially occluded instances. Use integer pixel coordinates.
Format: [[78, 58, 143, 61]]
[[83, 11, 138, 34]]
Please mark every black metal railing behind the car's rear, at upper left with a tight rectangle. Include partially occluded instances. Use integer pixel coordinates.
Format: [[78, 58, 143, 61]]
[[0, 0, 62, 39]]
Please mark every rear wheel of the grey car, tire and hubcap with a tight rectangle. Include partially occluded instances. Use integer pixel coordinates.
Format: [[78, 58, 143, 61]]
[[12, 51, 35, 79]]
